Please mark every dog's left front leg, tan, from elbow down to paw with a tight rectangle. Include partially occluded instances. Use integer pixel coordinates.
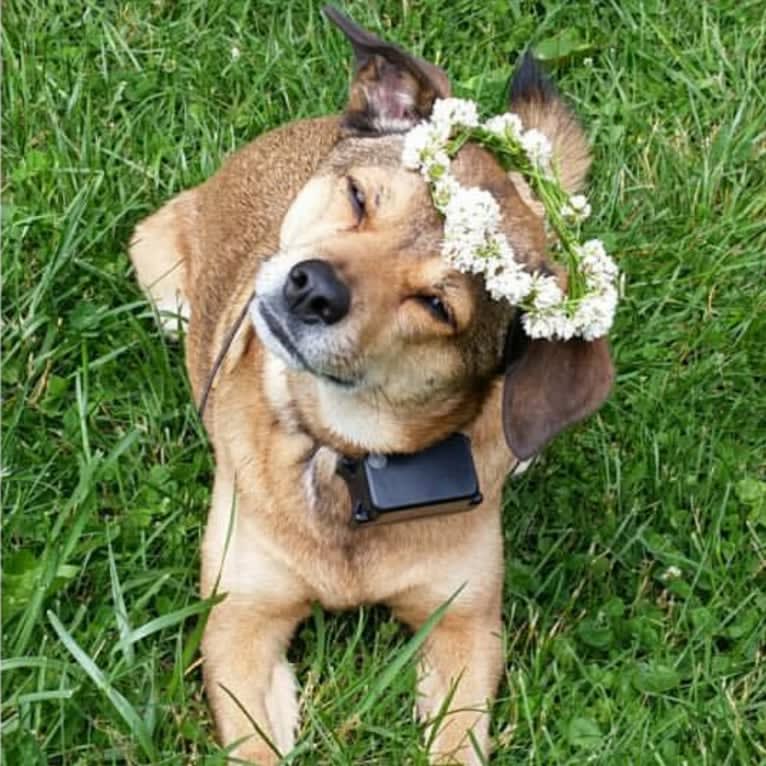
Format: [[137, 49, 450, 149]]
[[202, 595, 312, 766]]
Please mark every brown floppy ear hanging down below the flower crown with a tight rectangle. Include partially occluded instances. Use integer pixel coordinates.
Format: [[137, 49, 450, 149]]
[[503, 327, 614, 460]]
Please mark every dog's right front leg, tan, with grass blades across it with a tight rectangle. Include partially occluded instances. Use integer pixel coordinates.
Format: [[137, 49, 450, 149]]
[[392, 584, 502, 766]]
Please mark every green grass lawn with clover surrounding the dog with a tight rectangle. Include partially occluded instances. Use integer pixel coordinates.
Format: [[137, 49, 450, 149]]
[[2, 0, 766, 766]]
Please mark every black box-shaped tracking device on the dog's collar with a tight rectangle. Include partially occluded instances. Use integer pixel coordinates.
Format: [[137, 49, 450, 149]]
[[338, 434, 482, 525]]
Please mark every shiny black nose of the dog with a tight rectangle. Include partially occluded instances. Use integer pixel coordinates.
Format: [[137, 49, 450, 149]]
[[283, 258, 351, 324]]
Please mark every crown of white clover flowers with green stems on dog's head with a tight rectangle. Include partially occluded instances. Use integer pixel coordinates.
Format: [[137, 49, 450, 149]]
[[402, 98, 619, 340]]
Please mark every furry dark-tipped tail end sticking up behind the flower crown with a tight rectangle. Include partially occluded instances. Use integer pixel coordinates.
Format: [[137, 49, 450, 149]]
[[509, 53, 590, 194]]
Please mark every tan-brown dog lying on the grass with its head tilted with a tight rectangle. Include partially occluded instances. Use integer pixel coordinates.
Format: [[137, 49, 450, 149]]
[[131, 9, 613, 764]]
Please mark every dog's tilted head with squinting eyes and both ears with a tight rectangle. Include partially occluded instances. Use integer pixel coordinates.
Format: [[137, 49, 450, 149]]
[[251, 9, 613, 458]]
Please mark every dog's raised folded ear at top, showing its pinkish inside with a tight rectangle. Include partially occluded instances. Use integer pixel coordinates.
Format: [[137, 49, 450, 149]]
[[323, 5, 450, 135]]
